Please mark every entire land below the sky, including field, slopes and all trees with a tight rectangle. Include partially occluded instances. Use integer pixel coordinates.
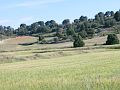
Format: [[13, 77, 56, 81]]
[[0, 10, 120, 90]]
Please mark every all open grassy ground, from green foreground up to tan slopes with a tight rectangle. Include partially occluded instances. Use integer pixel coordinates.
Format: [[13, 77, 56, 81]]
[[0, 37, 120, 90]]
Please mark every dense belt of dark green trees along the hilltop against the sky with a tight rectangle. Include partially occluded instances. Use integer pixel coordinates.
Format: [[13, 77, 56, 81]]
[[0, 10, 120, 44]]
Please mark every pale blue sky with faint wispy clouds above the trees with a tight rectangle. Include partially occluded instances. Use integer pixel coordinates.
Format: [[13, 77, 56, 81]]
[[0, 0, 120, 28]]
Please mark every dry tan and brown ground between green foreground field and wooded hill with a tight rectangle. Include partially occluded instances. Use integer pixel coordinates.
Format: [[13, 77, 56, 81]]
[[0, 35, 120, 63]]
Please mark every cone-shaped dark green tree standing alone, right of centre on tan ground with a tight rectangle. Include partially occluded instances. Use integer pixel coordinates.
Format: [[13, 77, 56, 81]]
[[73, 35, 85, 47]]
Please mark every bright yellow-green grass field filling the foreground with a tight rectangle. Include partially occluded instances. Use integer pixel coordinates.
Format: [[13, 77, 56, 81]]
[[0, 50, 120, 90]]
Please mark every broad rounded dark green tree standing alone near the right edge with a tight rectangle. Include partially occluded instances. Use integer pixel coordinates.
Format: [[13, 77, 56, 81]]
[[106, 34, 119, 45]]
